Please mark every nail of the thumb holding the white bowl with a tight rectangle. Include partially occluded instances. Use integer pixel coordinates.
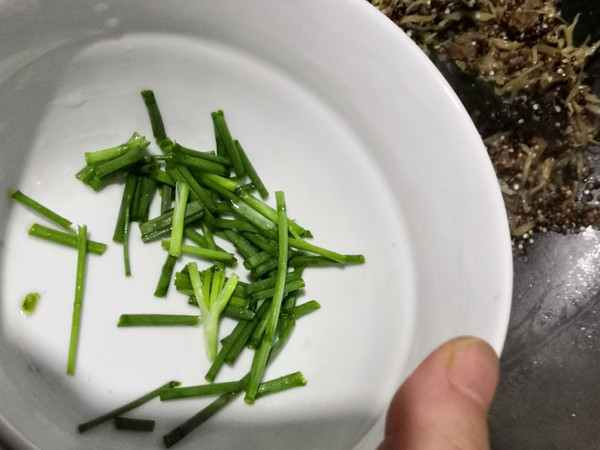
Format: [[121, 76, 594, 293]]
[[447, 337, 498, 408]]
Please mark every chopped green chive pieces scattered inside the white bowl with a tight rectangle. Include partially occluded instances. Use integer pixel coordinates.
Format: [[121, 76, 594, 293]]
[[11, 90, 365, 447]]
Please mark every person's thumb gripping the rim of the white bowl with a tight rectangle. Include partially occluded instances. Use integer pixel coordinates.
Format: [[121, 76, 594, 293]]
[[379, 337, 499, 450]]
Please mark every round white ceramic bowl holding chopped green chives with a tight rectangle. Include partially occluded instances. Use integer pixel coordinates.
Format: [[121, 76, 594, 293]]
[[0, 0, 511, 449]]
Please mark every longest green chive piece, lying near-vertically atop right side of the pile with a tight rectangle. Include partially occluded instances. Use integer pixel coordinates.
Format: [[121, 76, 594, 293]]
[[244, 191, 288, 404]]
